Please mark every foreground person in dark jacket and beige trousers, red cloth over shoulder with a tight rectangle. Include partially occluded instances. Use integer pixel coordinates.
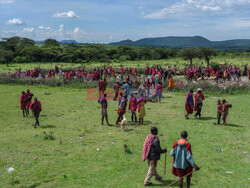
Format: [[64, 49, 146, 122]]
[[142, 127, 167, 186]]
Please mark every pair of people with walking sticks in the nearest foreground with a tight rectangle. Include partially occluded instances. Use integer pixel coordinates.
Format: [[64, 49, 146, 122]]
[[142, 127, 200, 188]]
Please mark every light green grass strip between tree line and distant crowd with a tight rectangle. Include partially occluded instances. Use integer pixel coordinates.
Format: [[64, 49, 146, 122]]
[[0, 56, 250, 73]]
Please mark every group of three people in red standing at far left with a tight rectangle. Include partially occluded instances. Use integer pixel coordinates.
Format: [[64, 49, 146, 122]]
[[20, 89, 42, 128]]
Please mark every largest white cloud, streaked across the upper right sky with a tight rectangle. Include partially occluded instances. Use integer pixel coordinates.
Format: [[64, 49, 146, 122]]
[[142, 0, 250, 19]]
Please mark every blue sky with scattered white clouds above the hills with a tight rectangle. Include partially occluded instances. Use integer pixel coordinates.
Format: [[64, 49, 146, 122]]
[[0, 0, 250, 43]]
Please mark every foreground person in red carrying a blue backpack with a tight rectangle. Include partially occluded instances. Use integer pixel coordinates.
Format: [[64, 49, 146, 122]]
[[170, 131, 200, 188]]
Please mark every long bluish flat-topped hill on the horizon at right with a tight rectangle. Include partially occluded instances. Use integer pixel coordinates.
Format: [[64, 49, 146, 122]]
[[110, 36, 250, 49]]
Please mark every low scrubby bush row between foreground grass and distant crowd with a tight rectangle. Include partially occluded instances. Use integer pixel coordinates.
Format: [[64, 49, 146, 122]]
[[0, 74, 250, 95]]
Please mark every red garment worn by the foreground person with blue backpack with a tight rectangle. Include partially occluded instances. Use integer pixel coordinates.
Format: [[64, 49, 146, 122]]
[[172, 141, 193, 177]]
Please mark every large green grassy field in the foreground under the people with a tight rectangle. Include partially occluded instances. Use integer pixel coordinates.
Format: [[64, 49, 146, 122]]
[[0, 85, 250, 187]]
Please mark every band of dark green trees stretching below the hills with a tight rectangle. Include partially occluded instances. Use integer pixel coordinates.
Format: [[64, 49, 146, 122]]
[[0, 36, 249, 65]]
